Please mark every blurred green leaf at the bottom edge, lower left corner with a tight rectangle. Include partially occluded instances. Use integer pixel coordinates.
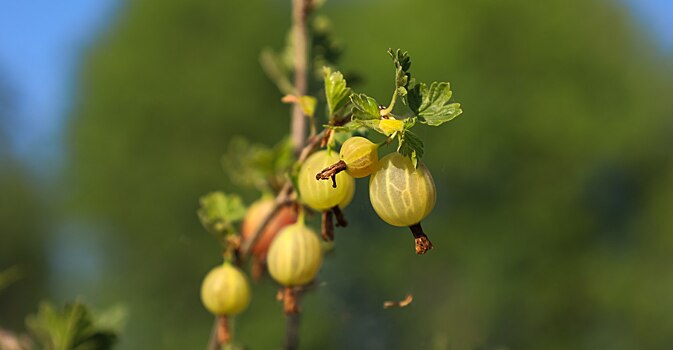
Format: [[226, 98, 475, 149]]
[[26, 302, 125, 350]]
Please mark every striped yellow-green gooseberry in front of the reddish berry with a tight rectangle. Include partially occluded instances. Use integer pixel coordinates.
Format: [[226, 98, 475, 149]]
[[266, 221, 322, 287]]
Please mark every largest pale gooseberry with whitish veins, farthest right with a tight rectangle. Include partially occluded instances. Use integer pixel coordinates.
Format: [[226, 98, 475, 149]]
[[369, 152, 437, 226]]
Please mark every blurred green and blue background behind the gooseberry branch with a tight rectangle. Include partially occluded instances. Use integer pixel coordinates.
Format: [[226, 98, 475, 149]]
[[0, 0, 673, 349]]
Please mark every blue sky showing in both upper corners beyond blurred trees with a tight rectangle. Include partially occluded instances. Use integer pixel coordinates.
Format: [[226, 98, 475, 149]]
[[0, 0, 673, 164]]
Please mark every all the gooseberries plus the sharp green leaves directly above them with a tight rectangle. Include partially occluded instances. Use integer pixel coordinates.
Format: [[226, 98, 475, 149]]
[[201, 46, 461, 348]]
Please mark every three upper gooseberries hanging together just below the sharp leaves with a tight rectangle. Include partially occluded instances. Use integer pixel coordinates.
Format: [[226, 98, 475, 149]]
[[298, 136, 437, 254]]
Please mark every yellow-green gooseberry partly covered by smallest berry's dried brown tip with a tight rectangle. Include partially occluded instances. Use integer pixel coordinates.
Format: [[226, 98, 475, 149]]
[[297, 151, 355, 211]]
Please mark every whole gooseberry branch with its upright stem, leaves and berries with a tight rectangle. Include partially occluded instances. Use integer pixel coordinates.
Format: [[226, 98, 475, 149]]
[[198, 0, 462, 349]]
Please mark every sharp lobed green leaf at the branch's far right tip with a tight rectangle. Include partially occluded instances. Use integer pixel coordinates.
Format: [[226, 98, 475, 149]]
[[407, 82, 463, 126]]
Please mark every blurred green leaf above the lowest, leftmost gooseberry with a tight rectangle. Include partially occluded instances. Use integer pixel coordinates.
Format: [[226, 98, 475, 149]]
[[197, 191, 246, 236]]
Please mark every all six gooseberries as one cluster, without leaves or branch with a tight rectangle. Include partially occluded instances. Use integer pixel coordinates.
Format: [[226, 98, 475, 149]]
[[201, 140, 436, 336]]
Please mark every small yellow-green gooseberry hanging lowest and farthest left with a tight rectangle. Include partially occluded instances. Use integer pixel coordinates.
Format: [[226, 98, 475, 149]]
[[201, 262, 250, 316]]
